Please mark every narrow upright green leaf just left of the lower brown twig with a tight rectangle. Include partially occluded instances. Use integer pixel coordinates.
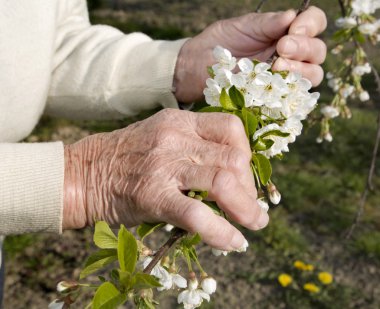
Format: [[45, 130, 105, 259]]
[[117, 225, 137, 273]]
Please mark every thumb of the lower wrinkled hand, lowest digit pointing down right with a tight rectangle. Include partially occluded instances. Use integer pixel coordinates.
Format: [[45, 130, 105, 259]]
[[165, 193, 245, 251]]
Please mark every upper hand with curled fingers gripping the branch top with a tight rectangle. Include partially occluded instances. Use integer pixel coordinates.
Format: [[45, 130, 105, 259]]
[[175, 6, 327, 102]]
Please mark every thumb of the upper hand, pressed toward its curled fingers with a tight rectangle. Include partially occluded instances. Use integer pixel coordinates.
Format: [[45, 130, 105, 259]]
[[251, 10, 297, 40]]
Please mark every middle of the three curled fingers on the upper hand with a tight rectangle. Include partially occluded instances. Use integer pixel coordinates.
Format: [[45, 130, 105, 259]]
[[277, 35, 327, 64]]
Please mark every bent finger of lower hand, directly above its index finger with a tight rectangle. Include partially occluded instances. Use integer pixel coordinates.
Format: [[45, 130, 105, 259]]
[[182, 138, 256, 196]]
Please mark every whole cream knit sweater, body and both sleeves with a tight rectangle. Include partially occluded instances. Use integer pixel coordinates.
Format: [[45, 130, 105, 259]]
[[0, 0, 184, 234]]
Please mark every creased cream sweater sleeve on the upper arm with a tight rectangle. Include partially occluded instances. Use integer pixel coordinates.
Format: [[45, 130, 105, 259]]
[[46, 0, 185, 119]]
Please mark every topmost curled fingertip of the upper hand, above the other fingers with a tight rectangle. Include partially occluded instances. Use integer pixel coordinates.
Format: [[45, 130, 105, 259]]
[[289, 6, 327, 37]]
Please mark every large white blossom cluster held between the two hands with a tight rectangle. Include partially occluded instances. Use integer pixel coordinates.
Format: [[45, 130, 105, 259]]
[[204, 46, 319, 158]]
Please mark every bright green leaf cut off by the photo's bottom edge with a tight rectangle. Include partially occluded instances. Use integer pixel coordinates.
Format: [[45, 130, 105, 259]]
[[92, 282, 127, 309]]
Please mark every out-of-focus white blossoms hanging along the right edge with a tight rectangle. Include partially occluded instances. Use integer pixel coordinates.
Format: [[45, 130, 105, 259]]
[[317, 0, 380, 143]]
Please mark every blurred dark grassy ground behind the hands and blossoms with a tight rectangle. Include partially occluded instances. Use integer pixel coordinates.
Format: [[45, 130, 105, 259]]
[[4, 0, 380, 309]]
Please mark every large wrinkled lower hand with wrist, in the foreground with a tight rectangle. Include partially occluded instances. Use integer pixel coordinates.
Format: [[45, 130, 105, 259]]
[[63, 109, 269, 250]]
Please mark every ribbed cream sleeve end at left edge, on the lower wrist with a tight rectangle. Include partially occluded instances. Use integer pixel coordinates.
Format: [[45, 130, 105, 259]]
[[0, 142, 64, 235]]
